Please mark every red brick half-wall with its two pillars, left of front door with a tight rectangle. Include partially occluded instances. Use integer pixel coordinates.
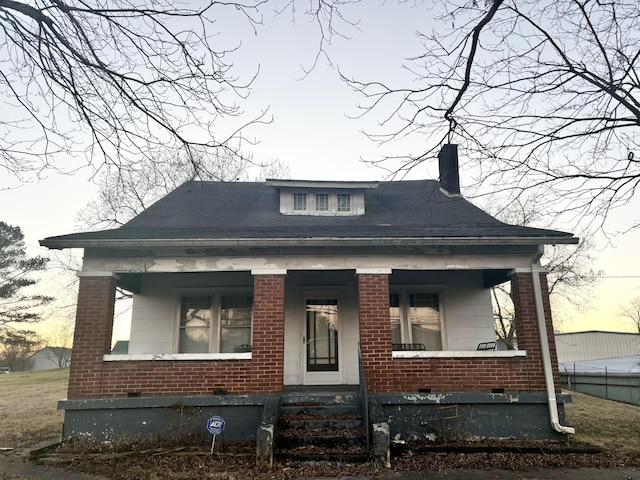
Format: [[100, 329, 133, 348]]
[[67, 275, 284, 399]]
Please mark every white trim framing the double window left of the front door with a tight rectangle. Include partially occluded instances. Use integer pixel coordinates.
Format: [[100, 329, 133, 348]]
[[176, 287, 253, 354]]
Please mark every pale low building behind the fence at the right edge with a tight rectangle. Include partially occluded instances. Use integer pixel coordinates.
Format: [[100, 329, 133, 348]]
[[555, 331, 640, 374]]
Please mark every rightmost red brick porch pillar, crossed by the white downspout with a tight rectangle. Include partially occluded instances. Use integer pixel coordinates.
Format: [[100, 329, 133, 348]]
[[511, 273, 560, 392]]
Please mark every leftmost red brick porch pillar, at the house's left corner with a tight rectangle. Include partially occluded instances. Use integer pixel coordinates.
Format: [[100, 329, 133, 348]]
[[67, 277, 116, 399]]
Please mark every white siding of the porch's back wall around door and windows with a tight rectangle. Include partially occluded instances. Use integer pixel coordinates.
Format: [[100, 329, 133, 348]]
[[129, 271, 495, 372]]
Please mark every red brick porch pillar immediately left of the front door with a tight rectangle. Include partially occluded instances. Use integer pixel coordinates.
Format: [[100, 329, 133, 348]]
[[251, 275, 285, 393]]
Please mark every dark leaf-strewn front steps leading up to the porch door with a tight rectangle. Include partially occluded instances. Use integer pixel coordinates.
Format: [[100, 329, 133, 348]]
[[274, 390, 369, 464]]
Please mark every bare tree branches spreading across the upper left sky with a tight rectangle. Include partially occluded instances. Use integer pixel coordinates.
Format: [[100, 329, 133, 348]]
[[0, 0, 267, 180]]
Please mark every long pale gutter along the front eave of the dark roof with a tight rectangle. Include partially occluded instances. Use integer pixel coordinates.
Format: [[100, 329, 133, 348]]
[[40, 236, 579, 249]]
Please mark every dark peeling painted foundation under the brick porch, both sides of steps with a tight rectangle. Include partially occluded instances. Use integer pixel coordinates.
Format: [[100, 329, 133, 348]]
[[58, 392, 571, 442]]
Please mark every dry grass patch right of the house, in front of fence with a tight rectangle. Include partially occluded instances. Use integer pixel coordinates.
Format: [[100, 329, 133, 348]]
[[566, 392, 640, 453]]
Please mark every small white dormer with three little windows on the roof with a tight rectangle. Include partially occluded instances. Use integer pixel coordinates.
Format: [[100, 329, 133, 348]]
[[267, 180, 378, 217]]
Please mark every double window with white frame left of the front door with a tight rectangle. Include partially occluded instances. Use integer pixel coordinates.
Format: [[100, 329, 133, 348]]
[[178, 294, 253, 353]]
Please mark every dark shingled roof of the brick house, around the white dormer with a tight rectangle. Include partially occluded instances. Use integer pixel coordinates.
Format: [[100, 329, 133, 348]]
[[41, 180, 573, 248]]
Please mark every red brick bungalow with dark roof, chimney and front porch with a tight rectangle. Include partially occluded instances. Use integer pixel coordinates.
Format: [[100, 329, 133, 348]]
[[41, 145, 577, 448]]
